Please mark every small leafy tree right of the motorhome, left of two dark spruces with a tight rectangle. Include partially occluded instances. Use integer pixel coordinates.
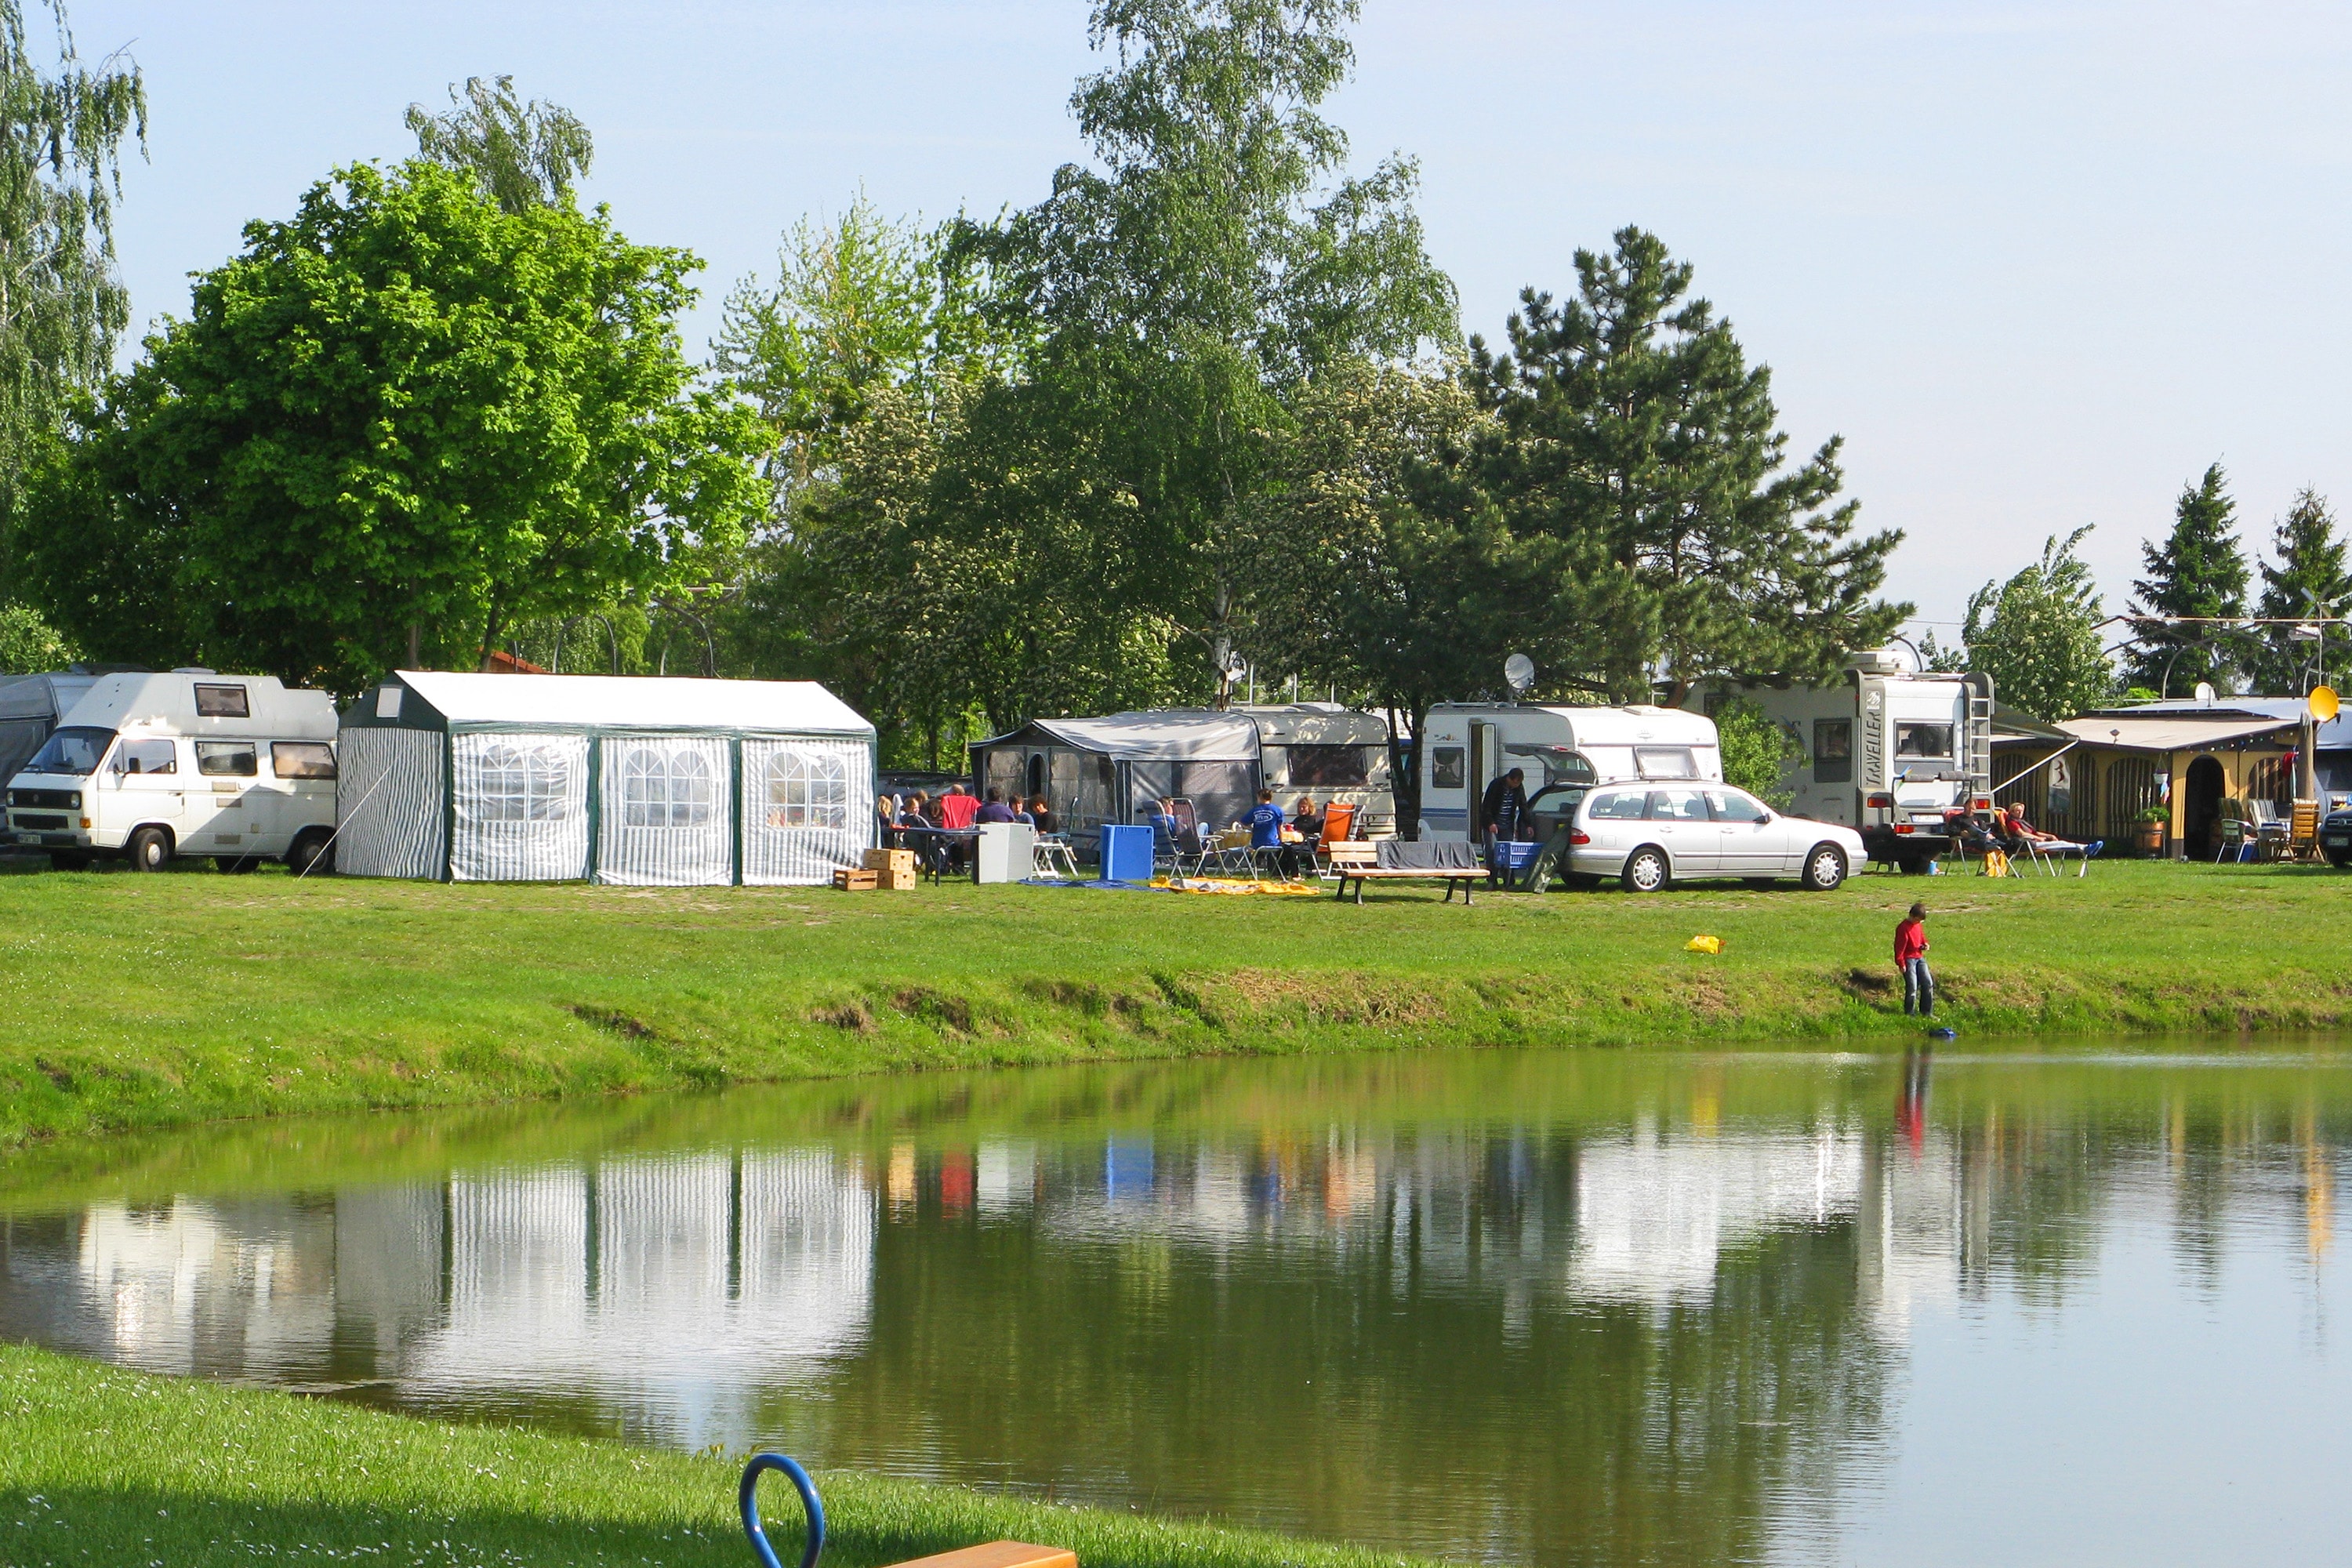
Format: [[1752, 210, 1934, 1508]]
[[1962, 524, 2114, 722]]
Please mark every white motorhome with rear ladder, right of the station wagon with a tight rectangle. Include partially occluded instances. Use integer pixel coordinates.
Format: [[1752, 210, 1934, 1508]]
[[1691, 649, 1992, 872]]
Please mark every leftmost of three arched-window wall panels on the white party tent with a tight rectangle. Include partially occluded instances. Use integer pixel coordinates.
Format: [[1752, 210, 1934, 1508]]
[[449, 731, 588, 881]]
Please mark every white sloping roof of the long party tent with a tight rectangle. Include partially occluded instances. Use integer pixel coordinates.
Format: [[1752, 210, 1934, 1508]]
[[395, 670, 875, 736]]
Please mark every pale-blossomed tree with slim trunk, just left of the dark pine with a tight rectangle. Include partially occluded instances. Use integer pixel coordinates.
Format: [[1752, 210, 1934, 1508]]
[[1225, 362, 1639, 829]]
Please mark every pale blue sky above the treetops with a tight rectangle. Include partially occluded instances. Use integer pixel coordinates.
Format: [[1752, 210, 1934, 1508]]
[[71, 0, 2352, 642]]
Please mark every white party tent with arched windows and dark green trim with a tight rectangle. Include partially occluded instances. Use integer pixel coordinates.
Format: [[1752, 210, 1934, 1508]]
[[334, 670, 875, 886]]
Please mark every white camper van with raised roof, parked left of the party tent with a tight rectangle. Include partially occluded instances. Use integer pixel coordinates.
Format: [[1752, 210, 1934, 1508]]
[[7, 670, 334, 872]]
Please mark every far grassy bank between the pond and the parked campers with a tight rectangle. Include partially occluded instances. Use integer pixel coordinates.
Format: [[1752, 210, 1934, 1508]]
[[0, 862, 2352, 1142]]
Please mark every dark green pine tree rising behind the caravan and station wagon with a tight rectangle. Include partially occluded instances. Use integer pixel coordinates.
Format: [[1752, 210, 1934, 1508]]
[[1470, 228, 1910, 706]]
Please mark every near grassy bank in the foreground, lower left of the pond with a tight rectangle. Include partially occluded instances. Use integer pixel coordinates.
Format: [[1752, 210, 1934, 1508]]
[[0, 1347, 1409, 1568]]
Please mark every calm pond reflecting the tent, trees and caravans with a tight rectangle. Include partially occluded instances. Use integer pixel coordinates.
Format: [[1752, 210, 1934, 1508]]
[[0, 1041, 2352, 1566]]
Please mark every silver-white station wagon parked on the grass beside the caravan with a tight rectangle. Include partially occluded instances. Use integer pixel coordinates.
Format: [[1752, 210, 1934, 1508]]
[[1566, 781, 1863, 893]]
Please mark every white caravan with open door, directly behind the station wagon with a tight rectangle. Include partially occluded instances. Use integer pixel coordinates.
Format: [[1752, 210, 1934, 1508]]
[[1414, 703, 1724, 839]]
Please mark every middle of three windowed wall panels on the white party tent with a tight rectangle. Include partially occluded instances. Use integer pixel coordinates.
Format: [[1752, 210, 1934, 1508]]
[[595, 736, 734, 886]]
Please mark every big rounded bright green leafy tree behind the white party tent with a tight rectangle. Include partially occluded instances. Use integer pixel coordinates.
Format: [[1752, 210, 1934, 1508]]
[[28, 160, 764, 689]]
